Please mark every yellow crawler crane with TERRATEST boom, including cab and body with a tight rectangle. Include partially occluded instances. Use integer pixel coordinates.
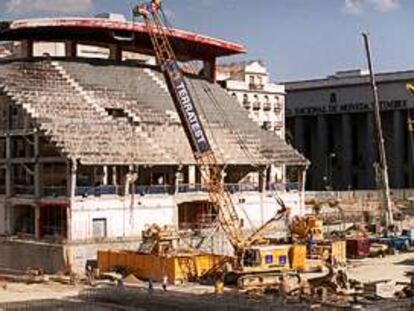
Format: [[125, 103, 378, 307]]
[[133, 0, 300, 287]]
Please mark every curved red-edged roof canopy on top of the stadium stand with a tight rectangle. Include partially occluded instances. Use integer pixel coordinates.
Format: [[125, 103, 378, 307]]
[[0, 18, 246, 60]]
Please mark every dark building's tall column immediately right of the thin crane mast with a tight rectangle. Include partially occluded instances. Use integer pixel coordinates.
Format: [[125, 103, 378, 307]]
[[387, 110, 405, 188]]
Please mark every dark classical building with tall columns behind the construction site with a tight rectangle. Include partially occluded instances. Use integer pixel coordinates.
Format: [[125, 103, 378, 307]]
[[285, 70, 414, 190]]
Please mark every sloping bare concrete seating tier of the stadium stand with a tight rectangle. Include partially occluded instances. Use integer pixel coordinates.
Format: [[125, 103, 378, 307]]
[[0, 60, 305, 165]]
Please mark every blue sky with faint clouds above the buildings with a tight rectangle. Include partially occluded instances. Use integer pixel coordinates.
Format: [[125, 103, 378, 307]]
[[0, 0, 414, 82]]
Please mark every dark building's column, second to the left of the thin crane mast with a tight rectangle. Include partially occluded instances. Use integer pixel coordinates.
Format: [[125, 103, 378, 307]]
[[340, 114, 352, 189]]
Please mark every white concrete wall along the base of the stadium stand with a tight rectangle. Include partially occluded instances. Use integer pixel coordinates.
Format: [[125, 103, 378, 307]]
[[71, 192, 301, 241]]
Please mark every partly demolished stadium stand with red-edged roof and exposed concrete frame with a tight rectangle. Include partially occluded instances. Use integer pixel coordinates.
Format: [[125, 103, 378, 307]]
[[0, 18, 308, 272]]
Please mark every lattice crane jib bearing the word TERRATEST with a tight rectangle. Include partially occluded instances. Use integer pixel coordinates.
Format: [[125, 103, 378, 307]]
[[133, 0, 244, 252]]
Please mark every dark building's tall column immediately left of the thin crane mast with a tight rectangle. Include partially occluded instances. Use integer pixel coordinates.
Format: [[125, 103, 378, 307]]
[[364, 113, 377, 189]]
